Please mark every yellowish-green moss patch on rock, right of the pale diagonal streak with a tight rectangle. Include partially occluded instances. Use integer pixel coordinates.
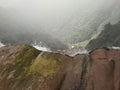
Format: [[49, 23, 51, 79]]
[[30, 53, 62, 78]]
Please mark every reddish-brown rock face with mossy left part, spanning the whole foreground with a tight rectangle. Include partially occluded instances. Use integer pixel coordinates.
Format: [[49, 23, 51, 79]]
[[0, 45, 120, 90]]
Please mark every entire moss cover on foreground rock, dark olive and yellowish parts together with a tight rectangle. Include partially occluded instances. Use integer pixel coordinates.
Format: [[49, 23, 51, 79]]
[[0, 45, 62, 79]]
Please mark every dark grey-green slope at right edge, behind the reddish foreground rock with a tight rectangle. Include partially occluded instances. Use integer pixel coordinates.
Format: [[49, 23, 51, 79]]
[[86, 22, 120, 50]]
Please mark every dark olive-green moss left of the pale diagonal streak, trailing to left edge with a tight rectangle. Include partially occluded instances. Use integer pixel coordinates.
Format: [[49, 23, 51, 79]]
[[0, 45, 40, 79]]
